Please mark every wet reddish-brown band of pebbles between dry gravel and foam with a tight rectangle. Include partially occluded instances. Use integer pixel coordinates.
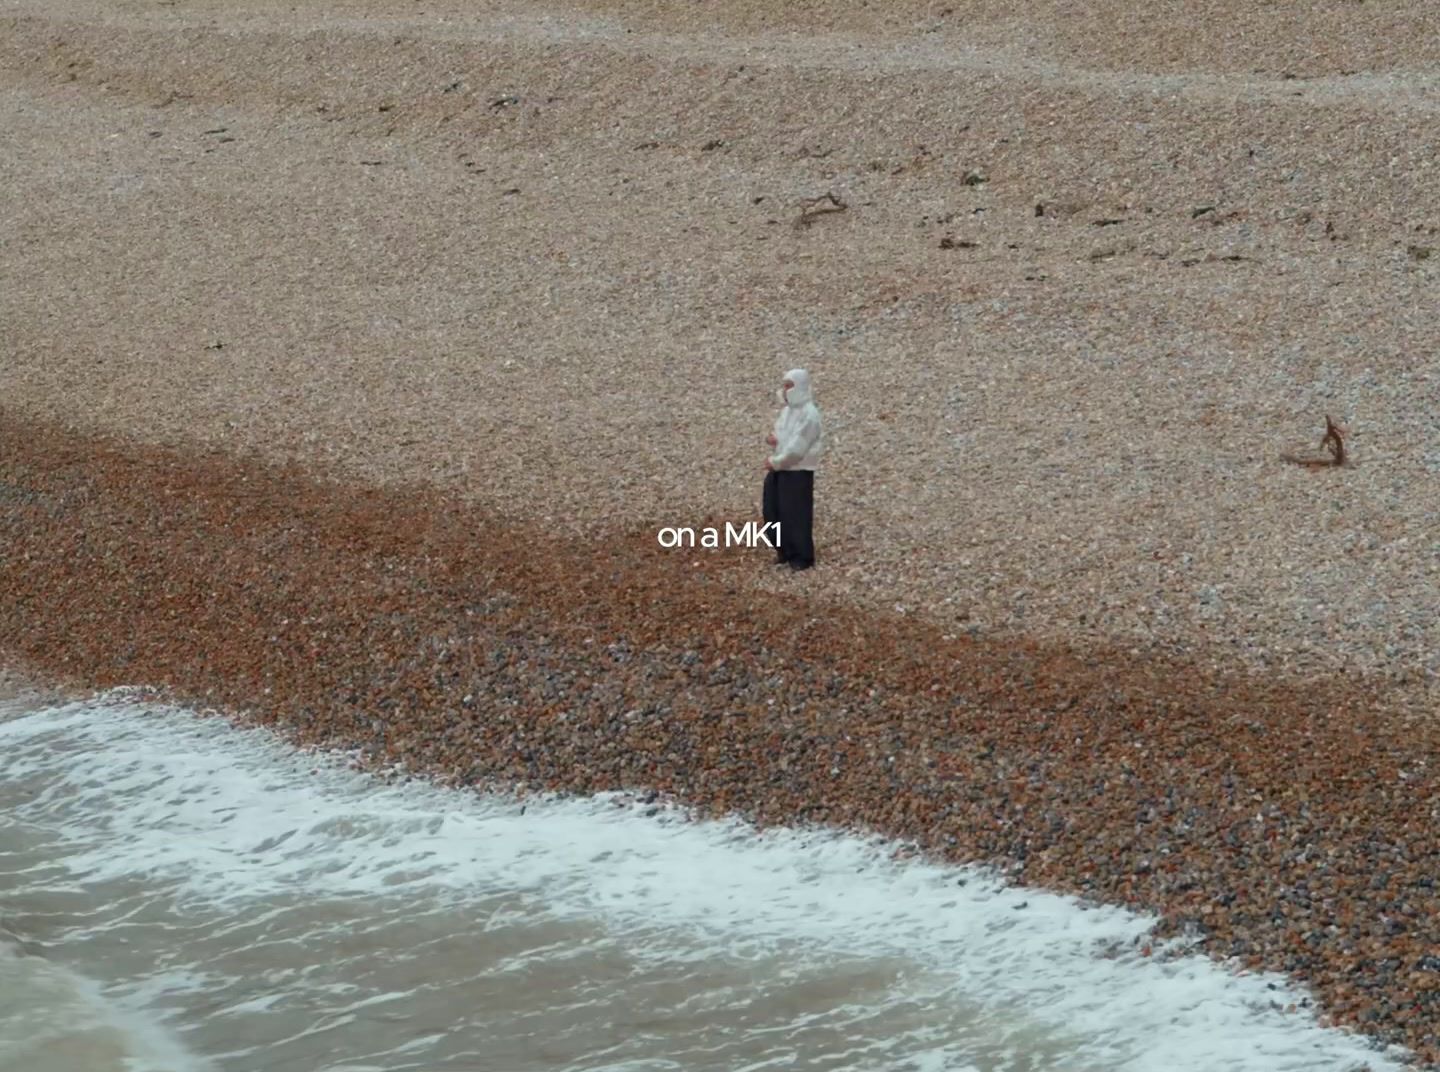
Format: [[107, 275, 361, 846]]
[[0, 419, 1440, 1062]]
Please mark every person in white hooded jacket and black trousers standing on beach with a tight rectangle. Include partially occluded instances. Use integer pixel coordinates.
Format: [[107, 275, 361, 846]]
[[763, 369, 824, 569]]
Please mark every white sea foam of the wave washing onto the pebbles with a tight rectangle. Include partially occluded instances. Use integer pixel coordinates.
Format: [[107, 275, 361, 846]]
[[0, 699, 1401, 1072]]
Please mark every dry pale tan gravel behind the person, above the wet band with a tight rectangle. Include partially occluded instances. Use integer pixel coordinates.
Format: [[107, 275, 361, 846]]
[[0, 0, 1440, 710]]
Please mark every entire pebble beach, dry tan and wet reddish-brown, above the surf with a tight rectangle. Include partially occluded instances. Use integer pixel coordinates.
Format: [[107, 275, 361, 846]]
[[0, 0, 1440, 1065]]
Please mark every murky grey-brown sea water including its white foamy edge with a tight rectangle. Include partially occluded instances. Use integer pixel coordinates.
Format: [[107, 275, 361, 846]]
[[0, 694, 1400, 1072]]
